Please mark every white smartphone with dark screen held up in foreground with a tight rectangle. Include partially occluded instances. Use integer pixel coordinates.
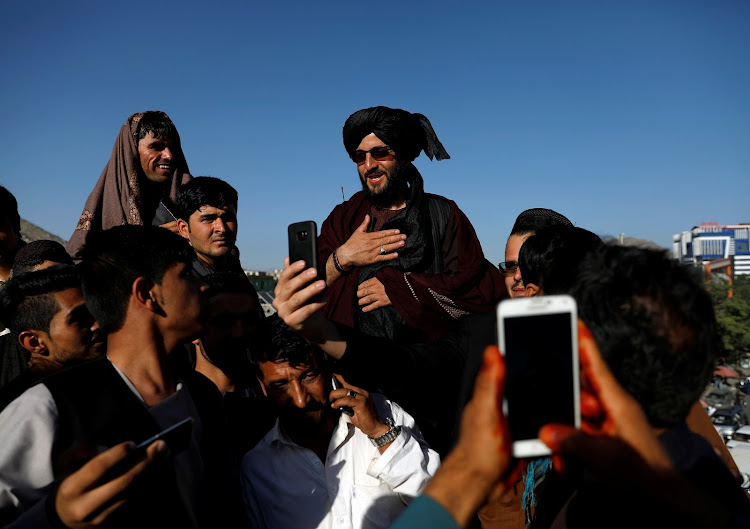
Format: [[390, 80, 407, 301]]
[[497, 295, 581, 458]]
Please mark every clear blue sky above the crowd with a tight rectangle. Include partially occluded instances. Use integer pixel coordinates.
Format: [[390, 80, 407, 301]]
[[0, 0, 750, 270]]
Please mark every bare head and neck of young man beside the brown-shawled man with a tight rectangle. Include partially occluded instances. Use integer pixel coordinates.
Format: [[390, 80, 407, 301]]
[[175, 176, 244, 277]]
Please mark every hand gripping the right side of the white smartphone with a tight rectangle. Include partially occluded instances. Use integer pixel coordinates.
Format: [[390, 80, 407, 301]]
[[539, 320, 737, 528]]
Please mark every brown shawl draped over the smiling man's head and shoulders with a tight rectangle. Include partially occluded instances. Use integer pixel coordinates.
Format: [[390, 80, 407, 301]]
[[66, 112, 192, 257]]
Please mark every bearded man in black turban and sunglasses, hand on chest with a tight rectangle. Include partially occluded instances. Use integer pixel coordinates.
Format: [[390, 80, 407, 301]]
[[318, 106, 504, 342]]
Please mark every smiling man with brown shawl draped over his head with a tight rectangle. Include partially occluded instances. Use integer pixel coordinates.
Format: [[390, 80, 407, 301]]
[[66, 110, 192, 258]]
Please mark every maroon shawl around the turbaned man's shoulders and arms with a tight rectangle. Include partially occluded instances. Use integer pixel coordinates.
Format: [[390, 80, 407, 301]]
[[318, 191, 505, 339]]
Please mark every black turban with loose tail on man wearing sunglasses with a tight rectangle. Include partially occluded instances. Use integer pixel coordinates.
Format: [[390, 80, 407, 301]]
[[344, 106, 450, 162]]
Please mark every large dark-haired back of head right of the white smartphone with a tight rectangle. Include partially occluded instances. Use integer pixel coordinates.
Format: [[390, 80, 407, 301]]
[[573, 246, 723, 427]]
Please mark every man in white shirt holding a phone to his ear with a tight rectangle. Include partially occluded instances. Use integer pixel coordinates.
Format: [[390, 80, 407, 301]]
[[241, 319, 440, 529]]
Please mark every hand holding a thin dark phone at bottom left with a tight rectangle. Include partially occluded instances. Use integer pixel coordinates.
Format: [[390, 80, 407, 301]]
[[54, 440, 167, 529]]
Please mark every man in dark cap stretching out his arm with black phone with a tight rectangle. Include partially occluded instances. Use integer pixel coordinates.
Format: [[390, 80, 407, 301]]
[[273, 208, 571, 455]]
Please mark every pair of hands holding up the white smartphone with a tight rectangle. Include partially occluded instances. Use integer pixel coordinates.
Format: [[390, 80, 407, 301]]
[[408, 320, 732, 529]]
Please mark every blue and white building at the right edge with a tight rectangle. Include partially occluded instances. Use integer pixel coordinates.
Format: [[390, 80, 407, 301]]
[[672, 222, 750, 280]]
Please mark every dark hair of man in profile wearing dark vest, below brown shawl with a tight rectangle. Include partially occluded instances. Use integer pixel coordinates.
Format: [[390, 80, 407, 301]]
[[80, 225, 195, 332]]
